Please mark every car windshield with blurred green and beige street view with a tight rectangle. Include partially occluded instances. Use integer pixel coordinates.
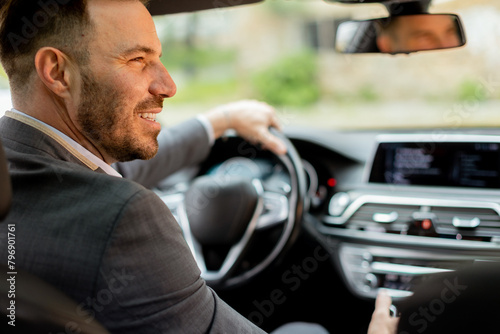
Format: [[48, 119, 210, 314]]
[[0, 0, 500, 129]]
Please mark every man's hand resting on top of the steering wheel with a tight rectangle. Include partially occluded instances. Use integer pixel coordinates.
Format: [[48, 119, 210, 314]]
[[206, 100, 287, 155]]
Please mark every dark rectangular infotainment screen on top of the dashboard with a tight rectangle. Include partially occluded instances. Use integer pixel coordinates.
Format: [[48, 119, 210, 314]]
[[368, 141, 500, 189]]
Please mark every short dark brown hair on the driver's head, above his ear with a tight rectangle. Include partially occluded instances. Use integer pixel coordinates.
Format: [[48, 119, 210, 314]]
[[0, 0, 148, 92]]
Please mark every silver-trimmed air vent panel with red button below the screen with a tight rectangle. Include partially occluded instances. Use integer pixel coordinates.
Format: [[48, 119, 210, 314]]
[[323, 191, 500, 243]]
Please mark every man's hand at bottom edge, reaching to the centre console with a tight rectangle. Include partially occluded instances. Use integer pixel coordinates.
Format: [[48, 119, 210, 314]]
[[368, 290, 399, 334]]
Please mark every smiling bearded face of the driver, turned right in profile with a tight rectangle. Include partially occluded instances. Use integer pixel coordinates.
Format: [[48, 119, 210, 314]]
[[77, 1, 176, 163]]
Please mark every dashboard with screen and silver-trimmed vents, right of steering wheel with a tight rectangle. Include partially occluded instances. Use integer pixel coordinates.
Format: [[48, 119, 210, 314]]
[[289, 128, 500, 300]]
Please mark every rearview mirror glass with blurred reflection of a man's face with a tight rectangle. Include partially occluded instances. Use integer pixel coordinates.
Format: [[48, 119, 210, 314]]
[[336, 14, 465, 54]]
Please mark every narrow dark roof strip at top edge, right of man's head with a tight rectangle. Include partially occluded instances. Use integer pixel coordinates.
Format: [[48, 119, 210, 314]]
[[148, 0, 264, 15]]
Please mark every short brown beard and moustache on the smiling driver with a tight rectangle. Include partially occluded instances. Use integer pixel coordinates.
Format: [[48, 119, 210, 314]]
[[77, 70, 163, 162]]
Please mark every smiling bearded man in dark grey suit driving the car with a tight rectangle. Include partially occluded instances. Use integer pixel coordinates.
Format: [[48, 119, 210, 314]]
[[0, 0, 324, 334]]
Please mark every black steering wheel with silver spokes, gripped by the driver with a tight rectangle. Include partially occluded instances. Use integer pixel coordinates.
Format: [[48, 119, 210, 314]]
[[161, 130, 306, 288]]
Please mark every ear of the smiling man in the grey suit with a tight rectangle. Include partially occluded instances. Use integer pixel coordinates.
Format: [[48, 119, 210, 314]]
[[35, 47, 75, 97]]
